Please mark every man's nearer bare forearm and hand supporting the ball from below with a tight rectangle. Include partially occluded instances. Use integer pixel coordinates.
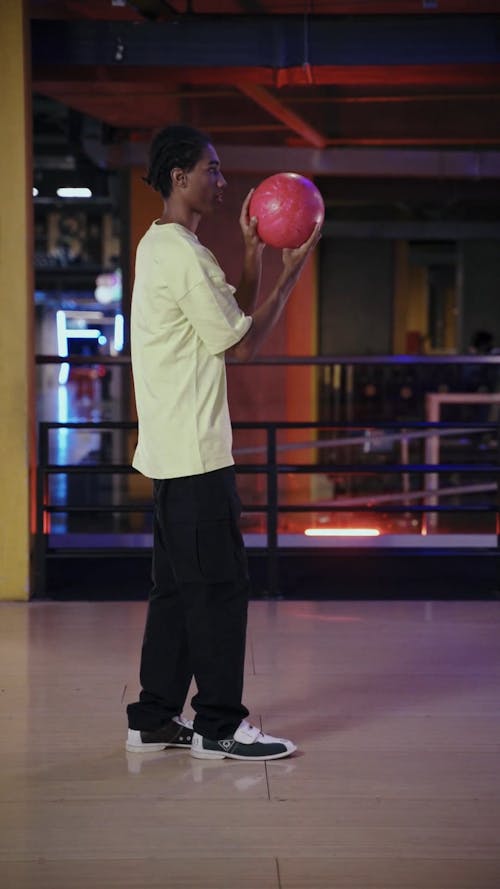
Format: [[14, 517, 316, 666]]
[[226, 225, 321, 361]]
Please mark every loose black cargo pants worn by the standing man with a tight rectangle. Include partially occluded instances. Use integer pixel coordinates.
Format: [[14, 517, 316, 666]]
[[127, 466, 249, 740]]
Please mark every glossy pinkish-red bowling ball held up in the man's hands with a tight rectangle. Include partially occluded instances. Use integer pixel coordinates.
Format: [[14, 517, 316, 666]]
[[249, 173, 325, 248]]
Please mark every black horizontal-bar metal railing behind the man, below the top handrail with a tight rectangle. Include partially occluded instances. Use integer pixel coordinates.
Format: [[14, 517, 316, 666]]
[[35, 420, 500, 596]]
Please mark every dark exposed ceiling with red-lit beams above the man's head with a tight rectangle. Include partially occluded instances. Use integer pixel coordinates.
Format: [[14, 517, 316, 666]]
[[31, 0, 500, 215]]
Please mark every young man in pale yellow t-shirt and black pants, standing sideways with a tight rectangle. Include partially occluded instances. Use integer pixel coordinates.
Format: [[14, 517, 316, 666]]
[[126, 125, 320, 760]]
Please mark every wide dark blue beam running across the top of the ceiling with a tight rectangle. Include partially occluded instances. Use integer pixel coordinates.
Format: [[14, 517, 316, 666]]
[[32, 16, 500, 68]]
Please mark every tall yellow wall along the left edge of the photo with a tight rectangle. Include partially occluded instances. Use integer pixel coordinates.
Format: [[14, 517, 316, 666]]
[[0, 3, 35, 599]]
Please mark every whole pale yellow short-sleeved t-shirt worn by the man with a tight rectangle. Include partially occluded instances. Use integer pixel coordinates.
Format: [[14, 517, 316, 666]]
[[131, 222, 252, 479]]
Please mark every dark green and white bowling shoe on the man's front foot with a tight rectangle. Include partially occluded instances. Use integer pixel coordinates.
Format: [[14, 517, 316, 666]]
[[191, 722, 297, 762]]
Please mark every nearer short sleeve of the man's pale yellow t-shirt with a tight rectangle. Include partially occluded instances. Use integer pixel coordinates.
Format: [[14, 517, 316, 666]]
[[178, 264, 252, 355]]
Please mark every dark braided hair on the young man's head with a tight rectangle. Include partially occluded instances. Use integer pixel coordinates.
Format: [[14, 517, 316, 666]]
[[143, 124, 211, 198]]
